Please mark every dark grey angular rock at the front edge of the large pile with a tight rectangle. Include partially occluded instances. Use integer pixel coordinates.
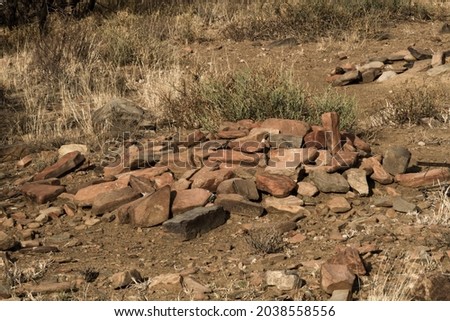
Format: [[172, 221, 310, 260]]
[[163, 206, 230, 240]]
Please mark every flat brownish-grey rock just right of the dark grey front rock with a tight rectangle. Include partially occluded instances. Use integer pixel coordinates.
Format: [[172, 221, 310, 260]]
[[214, 194, 264, 217]]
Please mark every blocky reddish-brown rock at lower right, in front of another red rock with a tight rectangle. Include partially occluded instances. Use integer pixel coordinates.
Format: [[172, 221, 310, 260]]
[[320, 263, 356, 294]]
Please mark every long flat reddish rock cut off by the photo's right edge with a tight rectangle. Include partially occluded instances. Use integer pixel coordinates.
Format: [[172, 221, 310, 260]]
[[395, 168, 450, 187]]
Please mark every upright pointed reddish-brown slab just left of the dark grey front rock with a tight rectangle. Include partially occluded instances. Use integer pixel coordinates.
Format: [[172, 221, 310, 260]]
[[128, 186, 170, 227]]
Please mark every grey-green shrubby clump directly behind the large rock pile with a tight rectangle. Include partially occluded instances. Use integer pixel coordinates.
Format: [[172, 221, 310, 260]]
[[163, 70, 356, 131]]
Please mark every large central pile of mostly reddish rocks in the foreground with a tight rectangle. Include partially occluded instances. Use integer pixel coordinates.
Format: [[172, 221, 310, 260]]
[[17, 112, 450, 239]]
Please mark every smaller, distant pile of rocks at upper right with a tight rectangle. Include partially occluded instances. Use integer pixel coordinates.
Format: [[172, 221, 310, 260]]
[[327, 47, 450, 86]]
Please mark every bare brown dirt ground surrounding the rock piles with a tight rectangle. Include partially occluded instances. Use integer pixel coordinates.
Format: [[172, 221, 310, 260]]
[[0, 23, 450, 300]]
